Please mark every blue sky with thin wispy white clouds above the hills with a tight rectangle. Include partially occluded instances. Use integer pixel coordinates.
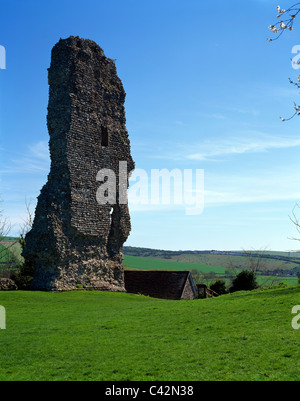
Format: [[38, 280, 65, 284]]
[[0, 0, 300, 251]]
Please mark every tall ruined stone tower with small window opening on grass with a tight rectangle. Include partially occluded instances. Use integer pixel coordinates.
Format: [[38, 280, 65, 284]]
[[23, 36, 134, 291]]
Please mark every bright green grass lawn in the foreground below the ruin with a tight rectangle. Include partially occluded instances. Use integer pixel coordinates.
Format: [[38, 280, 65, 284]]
[[0, 286, 300, 381]]
